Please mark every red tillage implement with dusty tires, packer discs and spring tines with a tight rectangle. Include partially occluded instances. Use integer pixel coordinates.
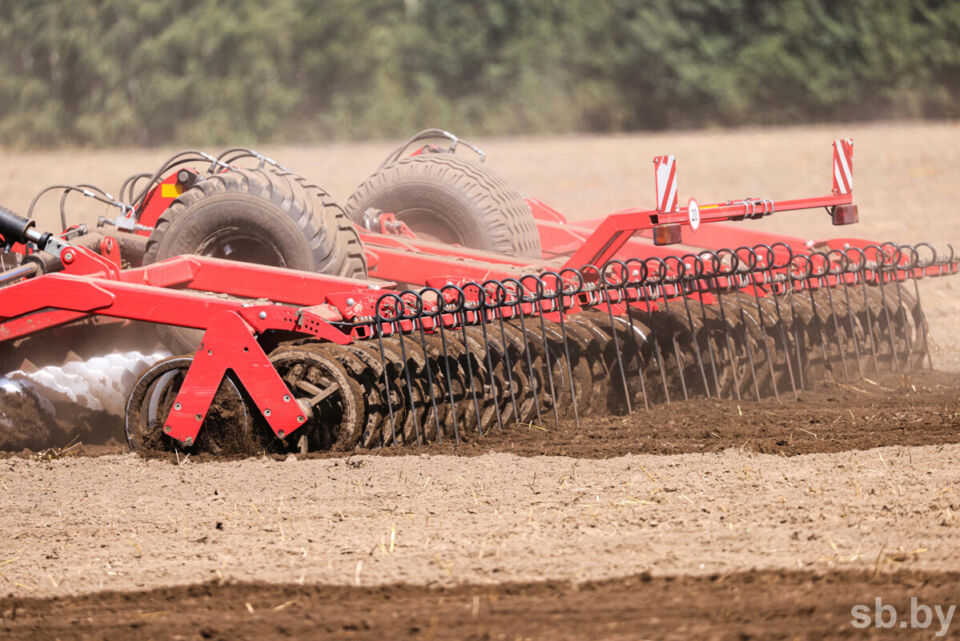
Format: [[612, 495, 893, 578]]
[[0, 132, 960, 454]]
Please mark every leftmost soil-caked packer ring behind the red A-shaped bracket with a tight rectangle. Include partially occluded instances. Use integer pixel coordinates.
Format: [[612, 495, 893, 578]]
[[124, 356, 258, 456]]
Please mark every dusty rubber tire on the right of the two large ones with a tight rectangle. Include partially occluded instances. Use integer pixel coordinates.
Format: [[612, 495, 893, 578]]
[[346, 154, 541, 259]]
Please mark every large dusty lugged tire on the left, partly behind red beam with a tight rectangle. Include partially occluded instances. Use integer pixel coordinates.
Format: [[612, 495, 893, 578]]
[[143, 167, 367, 354]]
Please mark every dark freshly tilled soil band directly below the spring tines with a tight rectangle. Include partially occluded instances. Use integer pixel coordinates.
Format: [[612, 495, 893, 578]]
[[396, 371, 960, 458]]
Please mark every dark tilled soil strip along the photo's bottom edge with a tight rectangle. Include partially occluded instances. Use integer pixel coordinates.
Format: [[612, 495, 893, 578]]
[[7, 572, 960, 641]]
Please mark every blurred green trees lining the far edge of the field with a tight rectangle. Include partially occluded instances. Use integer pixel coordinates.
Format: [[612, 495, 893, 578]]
[[0, 0, 960, 147]]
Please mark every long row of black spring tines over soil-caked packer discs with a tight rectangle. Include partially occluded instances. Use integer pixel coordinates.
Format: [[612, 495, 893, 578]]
[[316, 238, 953, 444]]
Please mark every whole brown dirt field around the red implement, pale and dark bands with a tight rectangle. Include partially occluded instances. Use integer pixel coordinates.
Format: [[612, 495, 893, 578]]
[[0, 123, 960, 640]]
